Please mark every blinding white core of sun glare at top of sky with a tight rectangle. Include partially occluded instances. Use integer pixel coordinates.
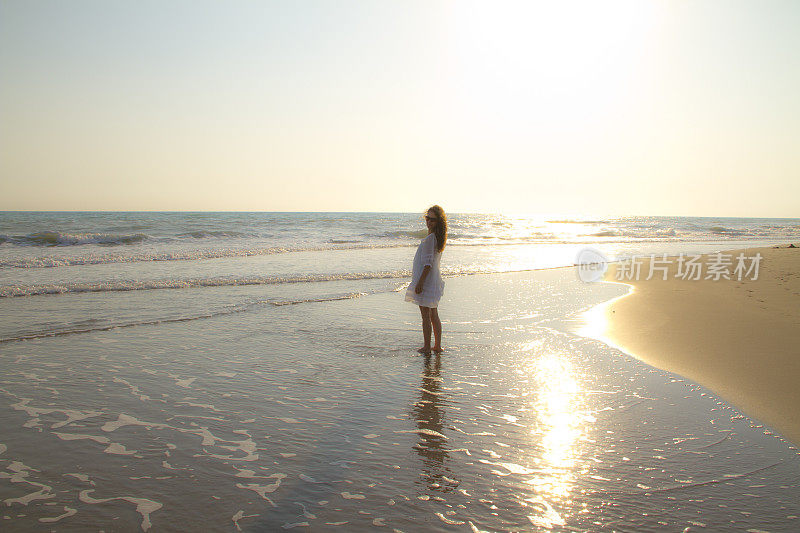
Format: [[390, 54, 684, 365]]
[[449, 1, 657, 136]]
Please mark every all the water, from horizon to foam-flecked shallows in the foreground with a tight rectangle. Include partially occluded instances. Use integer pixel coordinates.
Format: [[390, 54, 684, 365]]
[[0, 212, 800, 531]]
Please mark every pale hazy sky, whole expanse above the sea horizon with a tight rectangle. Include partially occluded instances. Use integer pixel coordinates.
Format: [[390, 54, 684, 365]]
[[0, 0, 800, 217]]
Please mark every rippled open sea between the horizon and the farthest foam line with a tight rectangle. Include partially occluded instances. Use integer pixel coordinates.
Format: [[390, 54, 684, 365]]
[[0, 212, 800, 268]]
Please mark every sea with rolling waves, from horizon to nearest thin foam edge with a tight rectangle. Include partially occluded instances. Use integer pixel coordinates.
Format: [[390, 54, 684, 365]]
[[0, 212, 800, 342]]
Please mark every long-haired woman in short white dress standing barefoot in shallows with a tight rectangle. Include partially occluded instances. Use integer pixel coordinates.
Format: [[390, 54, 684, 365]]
[[406, 205, 447, 354]]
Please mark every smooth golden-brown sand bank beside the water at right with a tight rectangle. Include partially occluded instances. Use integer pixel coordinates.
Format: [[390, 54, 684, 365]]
[[596, 244, 800, 444]]
